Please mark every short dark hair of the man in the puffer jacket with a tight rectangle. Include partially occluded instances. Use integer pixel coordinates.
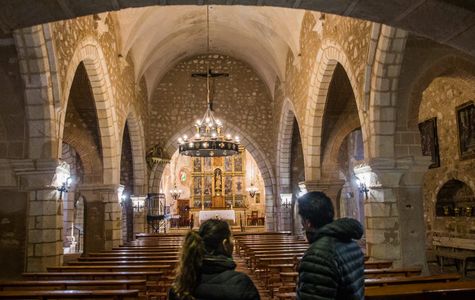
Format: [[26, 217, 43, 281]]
[[297, 192, 334, 228]]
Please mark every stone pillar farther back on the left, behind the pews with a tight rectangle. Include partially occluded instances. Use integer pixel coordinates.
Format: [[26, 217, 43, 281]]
[[78, 184, 122, 253]]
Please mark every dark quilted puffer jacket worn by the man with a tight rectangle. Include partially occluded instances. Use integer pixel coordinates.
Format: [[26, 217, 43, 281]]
[[297, 218, 364, 300]]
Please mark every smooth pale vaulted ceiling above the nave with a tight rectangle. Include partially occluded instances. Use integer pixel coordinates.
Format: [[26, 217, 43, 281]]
[[117, 6, 305, 92]]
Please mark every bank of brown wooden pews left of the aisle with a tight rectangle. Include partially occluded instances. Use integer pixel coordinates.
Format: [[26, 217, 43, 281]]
[[0, 236, 182, 299]]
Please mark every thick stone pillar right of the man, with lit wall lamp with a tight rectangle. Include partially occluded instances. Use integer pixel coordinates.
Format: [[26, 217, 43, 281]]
[[355, 158, 434, 269]]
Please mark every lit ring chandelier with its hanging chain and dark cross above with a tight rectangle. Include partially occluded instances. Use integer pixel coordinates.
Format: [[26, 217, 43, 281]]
[[178, 6, 240, 157]]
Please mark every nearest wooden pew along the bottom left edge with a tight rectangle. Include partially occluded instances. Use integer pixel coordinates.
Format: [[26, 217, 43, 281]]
[[0, 290, 139, 300]]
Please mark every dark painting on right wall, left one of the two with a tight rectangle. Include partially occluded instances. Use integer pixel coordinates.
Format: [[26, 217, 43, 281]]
[[419, 118, 440, 168]]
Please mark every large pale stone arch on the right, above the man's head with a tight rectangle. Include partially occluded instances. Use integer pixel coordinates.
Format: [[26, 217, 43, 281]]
[[303, 40, 362, 181]]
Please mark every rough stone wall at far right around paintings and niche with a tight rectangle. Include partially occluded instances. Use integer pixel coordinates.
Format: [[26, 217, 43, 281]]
[[419, 72, 475, 247]]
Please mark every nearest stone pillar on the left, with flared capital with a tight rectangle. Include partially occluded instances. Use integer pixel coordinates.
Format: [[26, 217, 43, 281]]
[[12, 160, 63, 272]]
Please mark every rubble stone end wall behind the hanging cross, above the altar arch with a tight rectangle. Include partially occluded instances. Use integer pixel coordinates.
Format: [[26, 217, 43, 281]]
[[148, 54, 274, 163]]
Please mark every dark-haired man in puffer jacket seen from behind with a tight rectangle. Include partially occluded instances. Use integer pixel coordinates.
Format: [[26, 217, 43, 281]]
[[297, 192, 364, 300]]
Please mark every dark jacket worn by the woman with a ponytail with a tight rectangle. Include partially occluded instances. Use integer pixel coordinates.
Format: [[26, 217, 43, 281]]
[[168, 255, 260, 300]]
